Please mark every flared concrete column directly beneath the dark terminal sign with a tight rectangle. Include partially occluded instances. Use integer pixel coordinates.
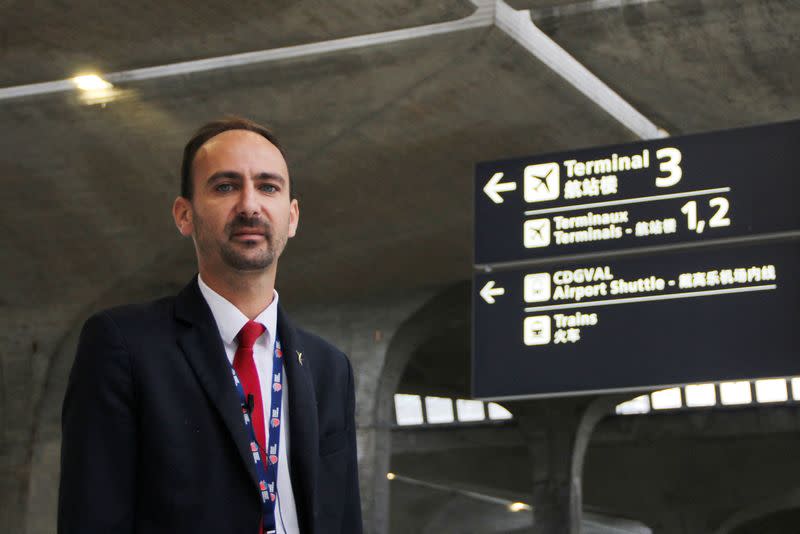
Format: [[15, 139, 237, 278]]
[[511, 395, 627, 534]]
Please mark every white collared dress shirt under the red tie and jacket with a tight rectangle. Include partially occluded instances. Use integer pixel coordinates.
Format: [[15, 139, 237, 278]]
[[197, 275, 299, 534]]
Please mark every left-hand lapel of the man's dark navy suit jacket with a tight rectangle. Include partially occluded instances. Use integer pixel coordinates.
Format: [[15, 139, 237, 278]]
[[175, 277, 258, 487]]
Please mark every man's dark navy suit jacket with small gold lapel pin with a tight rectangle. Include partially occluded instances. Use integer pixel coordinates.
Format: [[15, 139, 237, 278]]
[[58, 278, 362, 534]]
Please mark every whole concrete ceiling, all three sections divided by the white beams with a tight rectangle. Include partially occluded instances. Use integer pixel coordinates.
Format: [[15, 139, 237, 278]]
[[0, 0, 800, 314]]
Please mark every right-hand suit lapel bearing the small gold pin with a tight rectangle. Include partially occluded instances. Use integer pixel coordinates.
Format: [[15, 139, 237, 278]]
[[278, 304, 319, 533]]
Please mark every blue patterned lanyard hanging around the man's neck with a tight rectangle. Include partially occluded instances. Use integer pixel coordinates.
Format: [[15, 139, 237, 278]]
[[231, 336, 283, 534]]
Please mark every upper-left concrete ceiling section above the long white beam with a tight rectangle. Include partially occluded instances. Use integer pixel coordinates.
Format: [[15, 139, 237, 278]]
[[0, 0, 474, 87]]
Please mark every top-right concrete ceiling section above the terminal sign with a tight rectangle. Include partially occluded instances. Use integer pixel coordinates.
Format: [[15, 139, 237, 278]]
[[510, 0, 800, 135]]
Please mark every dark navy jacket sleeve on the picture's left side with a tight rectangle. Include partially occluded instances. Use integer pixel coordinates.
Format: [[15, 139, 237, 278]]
[[58, 313, 137, 534]]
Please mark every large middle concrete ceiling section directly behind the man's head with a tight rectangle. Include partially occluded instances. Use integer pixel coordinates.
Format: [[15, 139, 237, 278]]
[[0, 18, 632, 314]]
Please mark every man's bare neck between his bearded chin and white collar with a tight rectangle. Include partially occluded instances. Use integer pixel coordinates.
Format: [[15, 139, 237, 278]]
[[200, 267, 275, 319]]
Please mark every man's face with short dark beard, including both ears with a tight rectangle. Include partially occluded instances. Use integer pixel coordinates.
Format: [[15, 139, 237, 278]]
[[173, 130, 299, 274]]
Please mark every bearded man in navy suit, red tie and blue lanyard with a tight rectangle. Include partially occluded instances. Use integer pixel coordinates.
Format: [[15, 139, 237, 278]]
[[58, 118, 361, 534]]
